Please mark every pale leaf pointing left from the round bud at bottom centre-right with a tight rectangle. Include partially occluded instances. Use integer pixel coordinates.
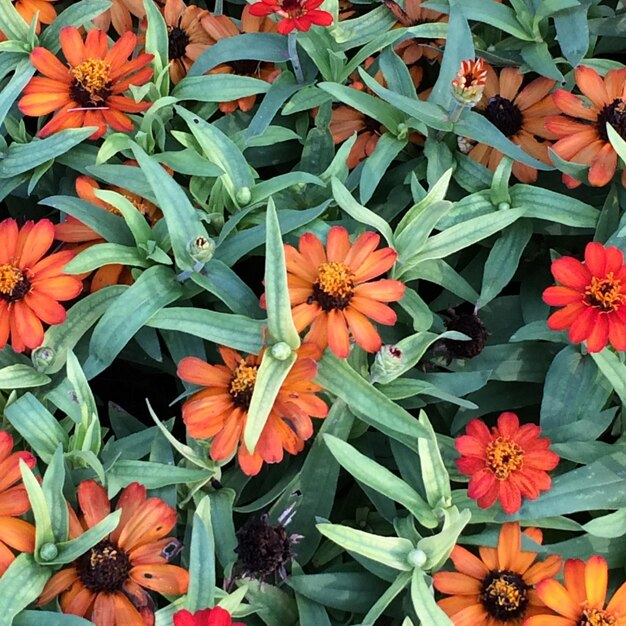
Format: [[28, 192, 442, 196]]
[[317, 524, 414, 572]]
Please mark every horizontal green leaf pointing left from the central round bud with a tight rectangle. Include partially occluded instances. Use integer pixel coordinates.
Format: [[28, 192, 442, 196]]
[[146, 307, 265, 354]]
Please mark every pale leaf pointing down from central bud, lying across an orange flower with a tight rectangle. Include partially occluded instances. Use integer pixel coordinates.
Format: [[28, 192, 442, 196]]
[[243, 350, 297, 452]]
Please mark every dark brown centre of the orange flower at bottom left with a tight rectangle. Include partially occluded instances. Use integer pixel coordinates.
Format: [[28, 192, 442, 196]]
[[76, 539, 131, 593]]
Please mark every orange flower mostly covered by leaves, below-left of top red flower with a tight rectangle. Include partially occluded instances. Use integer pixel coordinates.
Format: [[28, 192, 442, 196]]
[[200, 4, 280, 113]]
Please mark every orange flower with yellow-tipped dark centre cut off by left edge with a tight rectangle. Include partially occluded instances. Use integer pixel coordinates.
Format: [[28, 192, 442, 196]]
[[0, 218, 82, 352]]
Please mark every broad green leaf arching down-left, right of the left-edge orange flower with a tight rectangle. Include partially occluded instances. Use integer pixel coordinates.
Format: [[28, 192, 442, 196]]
[[84, 264, 182, 378]]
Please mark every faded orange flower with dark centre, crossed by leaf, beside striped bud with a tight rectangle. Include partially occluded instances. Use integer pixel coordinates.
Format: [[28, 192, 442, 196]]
[[469, 65, 558, 183]]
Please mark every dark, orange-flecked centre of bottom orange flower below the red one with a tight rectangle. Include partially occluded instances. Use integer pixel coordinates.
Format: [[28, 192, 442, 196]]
[[480, 570, 529, 622]]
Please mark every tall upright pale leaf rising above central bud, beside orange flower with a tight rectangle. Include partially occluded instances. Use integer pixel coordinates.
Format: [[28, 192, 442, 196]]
[[265, 198, 300, 350]]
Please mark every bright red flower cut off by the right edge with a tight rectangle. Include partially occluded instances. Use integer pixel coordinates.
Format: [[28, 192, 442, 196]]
[[543, 242, 626, 352]]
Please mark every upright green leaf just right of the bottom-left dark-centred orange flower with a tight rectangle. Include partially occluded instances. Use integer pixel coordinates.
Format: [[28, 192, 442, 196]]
[[186, 495, 215, 613]]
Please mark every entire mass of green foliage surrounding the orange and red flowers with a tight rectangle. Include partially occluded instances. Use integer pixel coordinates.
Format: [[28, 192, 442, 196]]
[[0, 0, 626, 626]]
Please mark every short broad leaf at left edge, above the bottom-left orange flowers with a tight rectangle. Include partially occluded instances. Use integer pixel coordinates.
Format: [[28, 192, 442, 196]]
[[4, 393, 69, 463]]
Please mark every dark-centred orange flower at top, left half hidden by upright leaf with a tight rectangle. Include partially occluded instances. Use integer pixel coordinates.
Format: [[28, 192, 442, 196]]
[[163, 0, 215, 84]]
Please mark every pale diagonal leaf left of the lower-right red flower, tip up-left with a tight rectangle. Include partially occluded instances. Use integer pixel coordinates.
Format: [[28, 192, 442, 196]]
[[324, 435, 437, 528]]
